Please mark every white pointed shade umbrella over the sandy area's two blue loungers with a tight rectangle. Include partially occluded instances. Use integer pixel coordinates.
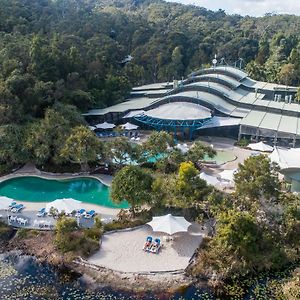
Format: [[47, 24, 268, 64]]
[[147, 214, 192, 235]]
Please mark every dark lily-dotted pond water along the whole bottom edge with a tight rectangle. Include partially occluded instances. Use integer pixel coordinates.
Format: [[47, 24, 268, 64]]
[[0, 252, 299, 300]]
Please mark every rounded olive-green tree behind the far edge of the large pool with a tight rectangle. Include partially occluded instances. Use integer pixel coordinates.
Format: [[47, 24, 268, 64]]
[[60, 125, 101, 172]]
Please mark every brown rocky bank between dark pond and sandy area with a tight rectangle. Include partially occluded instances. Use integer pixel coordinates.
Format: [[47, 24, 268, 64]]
[[0, 232, 198, 294]]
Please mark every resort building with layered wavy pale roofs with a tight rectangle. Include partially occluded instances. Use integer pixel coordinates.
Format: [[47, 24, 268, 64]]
[[85, 66, 300, 147]]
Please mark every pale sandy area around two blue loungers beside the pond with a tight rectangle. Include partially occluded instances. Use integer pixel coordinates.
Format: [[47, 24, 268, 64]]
[[88, 224, 204, 272]]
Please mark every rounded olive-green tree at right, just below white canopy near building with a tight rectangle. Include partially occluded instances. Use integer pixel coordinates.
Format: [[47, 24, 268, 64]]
[[234, 155, 280, 207]]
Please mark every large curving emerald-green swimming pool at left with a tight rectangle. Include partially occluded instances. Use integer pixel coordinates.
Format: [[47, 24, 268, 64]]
[[0, 176, 129, 208]]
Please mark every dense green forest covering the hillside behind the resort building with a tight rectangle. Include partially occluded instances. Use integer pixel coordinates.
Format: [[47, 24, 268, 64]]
[[0, 0, 300, 170]]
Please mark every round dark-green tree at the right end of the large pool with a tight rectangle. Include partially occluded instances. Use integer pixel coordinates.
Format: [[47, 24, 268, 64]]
[[110, 166, 153, 216]]
